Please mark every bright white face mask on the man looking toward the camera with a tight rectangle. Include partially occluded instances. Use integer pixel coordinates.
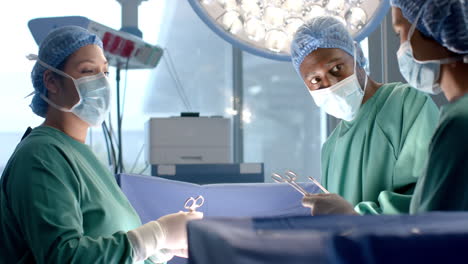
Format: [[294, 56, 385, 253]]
[[309, 43, 367, 121]]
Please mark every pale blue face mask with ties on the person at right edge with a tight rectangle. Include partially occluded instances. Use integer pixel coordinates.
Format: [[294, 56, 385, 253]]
[[397, 9, 466, 94]]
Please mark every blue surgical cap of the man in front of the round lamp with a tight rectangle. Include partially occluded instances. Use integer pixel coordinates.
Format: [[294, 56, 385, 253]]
[[291, 16, 366, 74]]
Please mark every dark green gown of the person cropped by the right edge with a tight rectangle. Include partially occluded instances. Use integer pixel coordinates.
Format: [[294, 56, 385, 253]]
[[410, 95, 468, 213]]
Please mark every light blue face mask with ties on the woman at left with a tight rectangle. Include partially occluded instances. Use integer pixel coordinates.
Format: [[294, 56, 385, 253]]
[[27, 54, 111, 126]]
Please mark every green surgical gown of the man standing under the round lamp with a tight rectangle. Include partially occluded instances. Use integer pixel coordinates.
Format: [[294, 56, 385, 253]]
[[321, 83, 439, 214]]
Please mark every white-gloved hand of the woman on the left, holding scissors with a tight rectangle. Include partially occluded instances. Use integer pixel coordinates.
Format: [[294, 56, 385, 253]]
[[127, 212, 203, 262]]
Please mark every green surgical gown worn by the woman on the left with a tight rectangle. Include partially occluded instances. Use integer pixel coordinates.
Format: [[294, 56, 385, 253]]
[[0, 126, 152, 263]]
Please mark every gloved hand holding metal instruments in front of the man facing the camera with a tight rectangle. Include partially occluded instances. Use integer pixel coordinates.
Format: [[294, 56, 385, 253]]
[[302, 193, 358, 215]]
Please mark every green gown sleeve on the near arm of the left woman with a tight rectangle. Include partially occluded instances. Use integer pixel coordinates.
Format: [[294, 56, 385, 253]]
[[8, 143, 133, 263]]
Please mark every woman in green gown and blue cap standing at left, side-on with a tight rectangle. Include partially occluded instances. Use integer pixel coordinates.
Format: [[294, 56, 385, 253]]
[[0, 26, 203, 263]]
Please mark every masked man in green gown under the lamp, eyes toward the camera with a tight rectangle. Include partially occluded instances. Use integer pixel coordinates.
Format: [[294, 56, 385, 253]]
[[291, 17, 439, 214]]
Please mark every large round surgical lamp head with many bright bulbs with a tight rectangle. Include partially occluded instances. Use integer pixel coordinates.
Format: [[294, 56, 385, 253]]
[[189, 0, 390, 61]]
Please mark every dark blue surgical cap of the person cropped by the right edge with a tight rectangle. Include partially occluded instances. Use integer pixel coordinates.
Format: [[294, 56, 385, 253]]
[[391, 0, 468, 54]]
